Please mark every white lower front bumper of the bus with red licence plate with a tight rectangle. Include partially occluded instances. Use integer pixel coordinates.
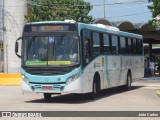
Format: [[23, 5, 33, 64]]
[[22, 78, 83, 94]]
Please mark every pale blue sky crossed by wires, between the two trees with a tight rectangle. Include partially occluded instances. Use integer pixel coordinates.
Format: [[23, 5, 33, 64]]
[[85, 0, 152, 23]]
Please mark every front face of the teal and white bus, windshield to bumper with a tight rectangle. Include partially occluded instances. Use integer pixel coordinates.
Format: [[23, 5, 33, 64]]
[[16, 22, 81, 99]]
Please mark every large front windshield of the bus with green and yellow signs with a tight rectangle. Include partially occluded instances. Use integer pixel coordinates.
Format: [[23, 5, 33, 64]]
[[23, 33, 79, 66]]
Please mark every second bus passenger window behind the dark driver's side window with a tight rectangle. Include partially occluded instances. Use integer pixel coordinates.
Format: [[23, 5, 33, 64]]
[[103, 34, 110, 53]]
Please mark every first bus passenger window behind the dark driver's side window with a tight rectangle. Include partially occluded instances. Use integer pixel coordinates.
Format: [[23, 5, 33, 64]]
[[93, 32, 100, 53]]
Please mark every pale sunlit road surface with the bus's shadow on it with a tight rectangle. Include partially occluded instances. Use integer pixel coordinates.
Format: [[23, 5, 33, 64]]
[[0, 80, 160, 120]]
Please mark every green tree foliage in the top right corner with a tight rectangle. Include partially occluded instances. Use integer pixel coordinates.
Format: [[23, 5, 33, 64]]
[[148, 0, 160, 27]]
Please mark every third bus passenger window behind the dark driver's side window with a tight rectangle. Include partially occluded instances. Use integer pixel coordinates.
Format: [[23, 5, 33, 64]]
[[111, 35, 119, 54]]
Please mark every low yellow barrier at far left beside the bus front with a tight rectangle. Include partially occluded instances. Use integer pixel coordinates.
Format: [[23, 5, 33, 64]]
[[0, 74, 21, 86]]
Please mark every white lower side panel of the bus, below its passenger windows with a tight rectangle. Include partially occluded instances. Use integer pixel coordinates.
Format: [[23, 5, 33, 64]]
[[82, 55, 143, 93]]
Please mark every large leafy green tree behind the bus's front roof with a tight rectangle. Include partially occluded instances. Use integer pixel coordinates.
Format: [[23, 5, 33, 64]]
[[25, 0, 93, 23]]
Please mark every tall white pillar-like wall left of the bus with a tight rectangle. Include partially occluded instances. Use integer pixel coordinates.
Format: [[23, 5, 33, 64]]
[[4, 0, 26, 73]]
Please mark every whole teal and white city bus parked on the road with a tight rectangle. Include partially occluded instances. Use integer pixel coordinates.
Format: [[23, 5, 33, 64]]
[[15, 20, 144, 99]]
